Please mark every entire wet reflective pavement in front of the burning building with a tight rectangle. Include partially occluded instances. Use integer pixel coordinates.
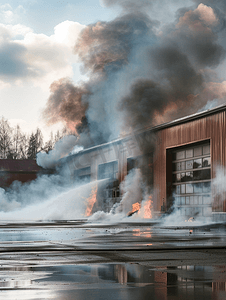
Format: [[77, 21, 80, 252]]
[[0, 220, 226, 300]]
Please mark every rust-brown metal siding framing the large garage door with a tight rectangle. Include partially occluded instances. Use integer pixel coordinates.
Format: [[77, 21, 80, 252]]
[[154, 111, 226, 211]]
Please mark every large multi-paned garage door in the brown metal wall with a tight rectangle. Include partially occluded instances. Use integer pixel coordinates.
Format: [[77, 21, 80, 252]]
[[173, 143, 212, 216]]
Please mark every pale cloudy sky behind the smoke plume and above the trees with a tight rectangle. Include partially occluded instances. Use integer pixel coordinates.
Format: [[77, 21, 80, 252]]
[[0, 0, 225, 141]]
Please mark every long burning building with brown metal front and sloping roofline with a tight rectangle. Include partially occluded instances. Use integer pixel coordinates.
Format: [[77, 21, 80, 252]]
[[62, 105, 226, 219]]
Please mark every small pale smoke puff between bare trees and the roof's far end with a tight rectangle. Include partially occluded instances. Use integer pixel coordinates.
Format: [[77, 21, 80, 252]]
[[37, 135, 79, 169]]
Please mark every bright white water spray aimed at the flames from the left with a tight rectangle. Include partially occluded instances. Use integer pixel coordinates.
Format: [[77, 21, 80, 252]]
[[0, 182, 97, 221]]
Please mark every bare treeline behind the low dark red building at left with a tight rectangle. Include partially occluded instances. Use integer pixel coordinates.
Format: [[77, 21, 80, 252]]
[[0, 117, 70, 159]]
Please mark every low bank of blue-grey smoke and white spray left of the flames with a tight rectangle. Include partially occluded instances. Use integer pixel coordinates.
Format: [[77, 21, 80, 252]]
[[0, 180, 96, 221]]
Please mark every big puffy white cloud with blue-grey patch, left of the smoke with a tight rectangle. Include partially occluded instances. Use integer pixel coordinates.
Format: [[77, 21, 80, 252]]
[[0, 21, 84, 88]]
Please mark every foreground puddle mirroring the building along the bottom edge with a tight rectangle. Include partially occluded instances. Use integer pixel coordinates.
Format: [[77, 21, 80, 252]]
[[0, 263, 226, 300]]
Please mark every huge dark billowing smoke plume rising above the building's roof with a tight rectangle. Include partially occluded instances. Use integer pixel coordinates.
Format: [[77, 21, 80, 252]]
[[42, 0, 226, 159]]
